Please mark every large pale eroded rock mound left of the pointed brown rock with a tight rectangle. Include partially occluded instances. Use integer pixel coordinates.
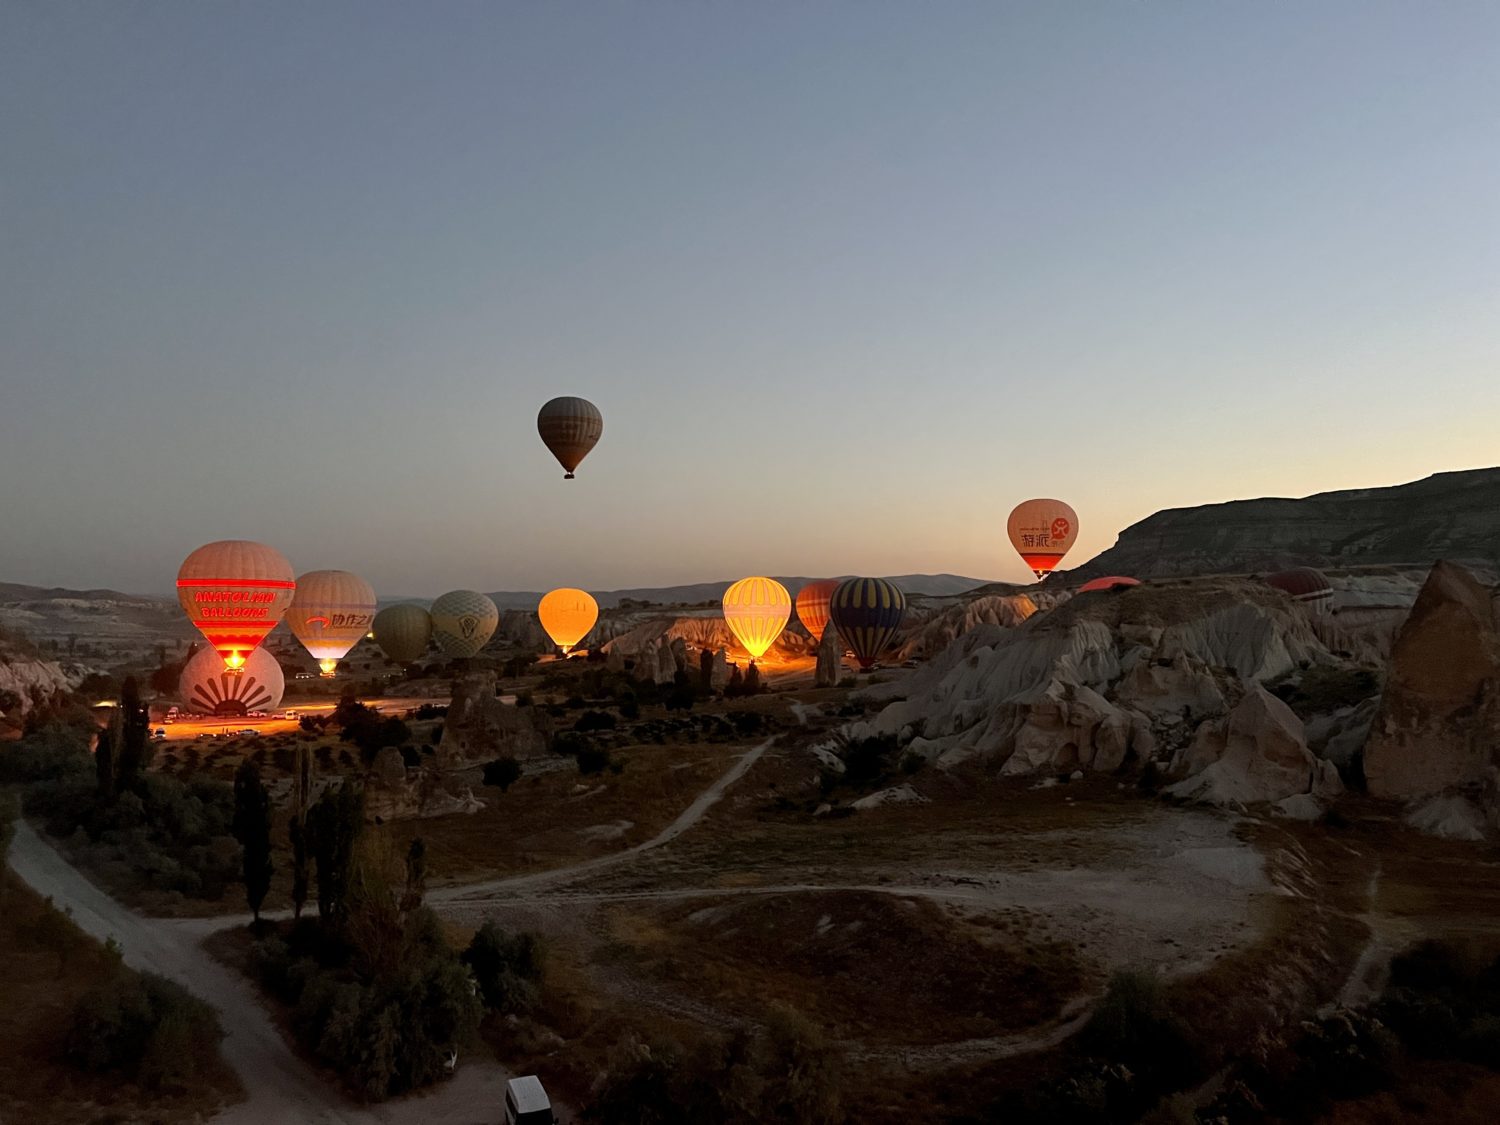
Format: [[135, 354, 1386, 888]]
[[845, 579, 1362, 815]]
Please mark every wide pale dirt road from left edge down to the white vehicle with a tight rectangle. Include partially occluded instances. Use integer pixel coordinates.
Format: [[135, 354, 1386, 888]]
[[9, 821, 534, 1125]]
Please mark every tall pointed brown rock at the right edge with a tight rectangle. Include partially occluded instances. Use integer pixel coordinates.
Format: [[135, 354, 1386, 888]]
[[1365, 563, 1500, 800]]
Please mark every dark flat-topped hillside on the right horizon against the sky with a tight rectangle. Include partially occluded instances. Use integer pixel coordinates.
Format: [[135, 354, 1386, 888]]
[[1068, 468, 1500, 579]]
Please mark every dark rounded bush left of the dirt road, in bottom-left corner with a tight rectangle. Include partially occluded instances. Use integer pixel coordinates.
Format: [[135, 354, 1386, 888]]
[[65, 968, 224, 1089]]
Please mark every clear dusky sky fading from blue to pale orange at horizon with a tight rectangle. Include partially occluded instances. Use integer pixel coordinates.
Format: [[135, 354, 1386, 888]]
[[0, 0, 1500, 596]]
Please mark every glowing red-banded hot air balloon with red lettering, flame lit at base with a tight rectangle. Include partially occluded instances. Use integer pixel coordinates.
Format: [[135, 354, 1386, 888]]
[[177, 539, 297, 672]]
